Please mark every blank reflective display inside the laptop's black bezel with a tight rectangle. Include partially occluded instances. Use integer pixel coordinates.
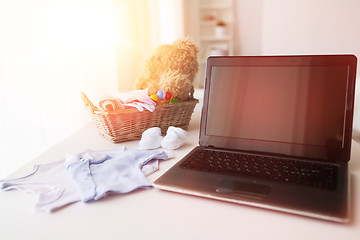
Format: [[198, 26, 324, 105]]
[[206, 66, 348, 158]]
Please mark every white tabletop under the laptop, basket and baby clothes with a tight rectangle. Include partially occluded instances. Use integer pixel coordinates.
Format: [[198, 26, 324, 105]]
[[0, 96, 360, 240]]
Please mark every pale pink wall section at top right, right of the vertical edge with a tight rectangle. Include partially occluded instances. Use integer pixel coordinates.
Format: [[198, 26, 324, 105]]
[[262, 0, 360, 56]]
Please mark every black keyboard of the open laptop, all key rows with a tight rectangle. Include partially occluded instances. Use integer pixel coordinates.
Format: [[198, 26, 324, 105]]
[[181, 150, 338, 190]]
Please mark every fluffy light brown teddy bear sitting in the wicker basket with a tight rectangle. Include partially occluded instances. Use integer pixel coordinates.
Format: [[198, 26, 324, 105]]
[[135, 38, 199, 101]]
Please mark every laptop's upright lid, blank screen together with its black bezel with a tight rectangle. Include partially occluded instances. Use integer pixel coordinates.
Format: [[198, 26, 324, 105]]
[[202, 56, 354, 161]]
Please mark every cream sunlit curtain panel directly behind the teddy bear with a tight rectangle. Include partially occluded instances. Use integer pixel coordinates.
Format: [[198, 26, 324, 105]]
[[113, 0, 185, 90]]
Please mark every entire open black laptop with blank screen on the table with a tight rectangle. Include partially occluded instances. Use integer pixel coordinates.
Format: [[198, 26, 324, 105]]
[[154, 55, 357, 222]]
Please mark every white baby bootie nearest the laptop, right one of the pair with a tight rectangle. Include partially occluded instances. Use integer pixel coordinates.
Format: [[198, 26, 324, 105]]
[[161, 126, 187, 149]]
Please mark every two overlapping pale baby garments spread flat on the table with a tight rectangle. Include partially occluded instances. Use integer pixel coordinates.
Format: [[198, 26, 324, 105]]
[[0, 147, 168, 212]]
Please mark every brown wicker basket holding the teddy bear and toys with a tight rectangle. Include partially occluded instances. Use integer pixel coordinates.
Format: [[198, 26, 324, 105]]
[[81, 92, 199, 143]]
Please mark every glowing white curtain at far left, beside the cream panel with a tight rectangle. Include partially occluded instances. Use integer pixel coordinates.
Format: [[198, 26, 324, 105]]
[[0, 0, 117, 177]]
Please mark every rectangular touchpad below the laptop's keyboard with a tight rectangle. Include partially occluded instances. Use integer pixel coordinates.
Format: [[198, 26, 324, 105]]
[[216, 179, 270, 198]]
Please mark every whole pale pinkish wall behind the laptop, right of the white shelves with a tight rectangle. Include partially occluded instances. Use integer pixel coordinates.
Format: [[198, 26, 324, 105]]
[[235, 0, 360, 138]]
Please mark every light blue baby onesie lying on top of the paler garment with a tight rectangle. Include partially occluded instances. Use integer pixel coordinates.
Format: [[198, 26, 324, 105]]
[[66, 150, 168, 202]]
